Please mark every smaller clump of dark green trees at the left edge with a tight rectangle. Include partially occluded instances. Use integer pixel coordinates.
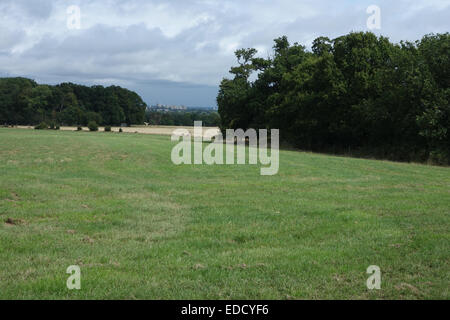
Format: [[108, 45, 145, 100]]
[[0, 78, 147, 126]]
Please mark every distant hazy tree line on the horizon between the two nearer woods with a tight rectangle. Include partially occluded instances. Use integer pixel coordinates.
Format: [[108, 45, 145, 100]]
[[146, 110, 220, 127]]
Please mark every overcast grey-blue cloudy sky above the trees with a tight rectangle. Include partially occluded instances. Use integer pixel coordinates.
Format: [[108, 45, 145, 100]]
[[0, 0, 450, 107]]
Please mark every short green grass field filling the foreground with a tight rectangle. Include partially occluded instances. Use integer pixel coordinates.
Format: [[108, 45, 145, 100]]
[[0, 129, 450, 299]]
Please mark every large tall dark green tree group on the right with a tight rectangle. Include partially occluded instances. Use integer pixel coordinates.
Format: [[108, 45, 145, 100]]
[[217, 32, 450, 163]]
